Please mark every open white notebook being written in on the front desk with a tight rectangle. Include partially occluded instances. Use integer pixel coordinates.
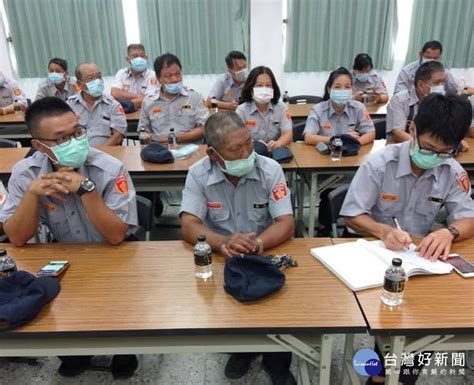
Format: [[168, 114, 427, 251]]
[[311, 239, 453, 291]]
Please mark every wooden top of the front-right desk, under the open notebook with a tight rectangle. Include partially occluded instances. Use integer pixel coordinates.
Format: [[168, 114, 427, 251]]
[[334, 239, 474, 335]]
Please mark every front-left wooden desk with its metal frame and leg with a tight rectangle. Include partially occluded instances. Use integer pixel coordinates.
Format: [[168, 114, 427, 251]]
[[0, 238, 366, 384]]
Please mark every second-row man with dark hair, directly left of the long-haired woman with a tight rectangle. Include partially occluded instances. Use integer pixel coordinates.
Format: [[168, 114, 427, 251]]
[[138, 53, 209, 143]]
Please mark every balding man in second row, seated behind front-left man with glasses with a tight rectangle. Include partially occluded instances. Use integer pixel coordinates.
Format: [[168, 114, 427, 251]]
[[67, 63, 127, 146]]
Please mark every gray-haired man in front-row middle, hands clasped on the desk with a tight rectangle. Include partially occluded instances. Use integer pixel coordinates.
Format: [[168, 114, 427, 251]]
[[180, 111, 296, 384]]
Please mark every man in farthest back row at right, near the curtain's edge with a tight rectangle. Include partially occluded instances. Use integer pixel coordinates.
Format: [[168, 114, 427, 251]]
[[393, 40, 474, 95]]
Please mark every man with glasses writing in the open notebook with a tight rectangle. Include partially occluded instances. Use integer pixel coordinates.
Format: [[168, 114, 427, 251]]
[[341, 94, 474, 260]]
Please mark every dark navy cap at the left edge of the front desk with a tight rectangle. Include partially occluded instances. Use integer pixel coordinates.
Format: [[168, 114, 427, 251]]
[[0, 271, 60, 330]]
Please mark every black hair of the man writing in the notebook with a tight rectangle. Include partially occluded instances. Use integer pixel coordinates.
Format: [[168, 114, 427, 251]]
[[414, 93, 472, 146]]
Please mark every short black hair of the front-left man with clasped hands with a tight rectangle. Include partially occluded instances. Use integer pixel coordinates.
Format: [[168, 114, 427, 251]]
[[25, 96, 74, 138]]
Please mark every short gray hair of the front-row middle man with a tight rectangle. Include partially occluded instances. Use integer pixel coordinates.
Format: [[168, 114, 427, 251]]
[[204, 111, 246, 149]]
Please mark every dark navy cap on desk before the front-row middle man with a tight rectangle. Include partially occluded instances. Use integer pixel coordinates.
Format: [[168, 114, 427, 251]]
[[224, 255, 285, 302]]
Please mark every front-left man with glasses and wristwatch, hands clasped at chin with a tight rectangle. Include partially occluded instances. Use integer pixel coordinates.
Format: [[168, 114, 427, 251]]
[[0, 97, 138, 376]]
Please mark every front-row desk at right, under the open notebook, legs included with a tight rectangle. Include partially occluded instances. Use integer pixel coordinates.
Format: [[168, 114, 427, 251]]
[[332, 238, 474, 385]]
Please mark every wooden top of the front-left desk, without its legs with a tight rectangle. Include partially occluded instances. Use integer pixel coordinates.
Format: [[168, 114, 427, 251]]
[[5, 238, 366, 336]]
